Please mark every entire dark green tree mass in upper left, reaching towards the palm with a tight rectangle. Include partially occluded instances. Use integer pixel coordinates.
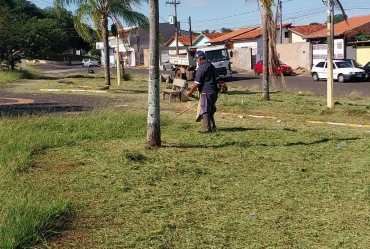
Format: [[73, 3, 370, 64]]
[[0, 0, 96, 69]]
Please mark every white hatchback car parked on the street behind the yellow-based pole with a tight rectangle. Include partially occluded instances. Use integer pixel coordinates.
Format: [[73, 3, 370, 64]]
[[311, 60, 365, 83]]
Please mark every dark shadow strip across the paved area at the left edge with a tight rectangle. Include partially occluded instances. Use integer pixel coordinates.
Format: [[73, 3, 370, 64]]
[[0, 103, 93, 117]]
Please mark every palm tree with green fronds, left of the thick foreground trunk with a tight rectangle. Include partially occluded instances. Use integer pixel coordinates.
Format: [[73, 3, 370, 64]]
[[54, 0, 149, 87]]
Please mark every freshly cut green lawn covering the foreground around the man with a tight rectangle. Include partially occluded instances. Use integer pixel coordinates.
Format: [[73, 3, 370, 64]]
[[0, 68, 370, 249]]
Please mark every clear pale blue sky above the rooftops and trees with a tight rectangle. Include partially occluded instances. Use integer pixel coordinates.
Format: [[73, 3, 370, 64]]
[[30, 0, 370, 32]]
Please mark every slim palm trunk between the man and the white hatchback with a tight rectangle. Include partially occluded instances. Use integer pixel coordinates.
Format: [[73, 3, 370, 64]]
[[262, 6, 270, 100]]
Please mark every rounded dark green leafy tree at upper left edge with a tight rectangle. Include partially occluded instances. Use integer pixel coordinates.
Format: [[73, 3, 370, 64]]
[[0, 0, 68, 69]]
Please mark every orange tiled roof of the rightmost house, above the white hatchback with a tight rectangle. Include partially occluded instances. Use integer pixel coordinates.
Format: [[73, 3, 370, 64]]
[[307, 15, 370, 38]]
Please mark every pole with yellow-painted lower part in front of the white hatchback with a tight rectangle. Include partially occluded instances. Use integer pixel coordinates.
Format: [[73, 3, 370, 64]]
[[325, 0, 334, 109]]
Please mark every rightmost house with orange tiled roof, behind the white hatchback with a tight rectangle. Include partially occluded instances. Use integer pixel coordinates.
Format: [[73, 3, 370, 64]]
[[304, 15, 370, 65]]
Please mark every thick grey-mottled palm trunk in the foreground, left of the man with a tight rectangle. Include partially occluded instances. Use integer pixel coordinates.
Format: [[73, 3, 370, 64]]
[[146, 0, 161, 146]]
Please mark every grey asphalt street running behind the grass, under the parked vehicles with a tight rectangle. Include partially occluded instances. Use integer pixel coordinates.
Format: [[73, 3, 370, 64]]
[[26, 65, 370, 97]]
